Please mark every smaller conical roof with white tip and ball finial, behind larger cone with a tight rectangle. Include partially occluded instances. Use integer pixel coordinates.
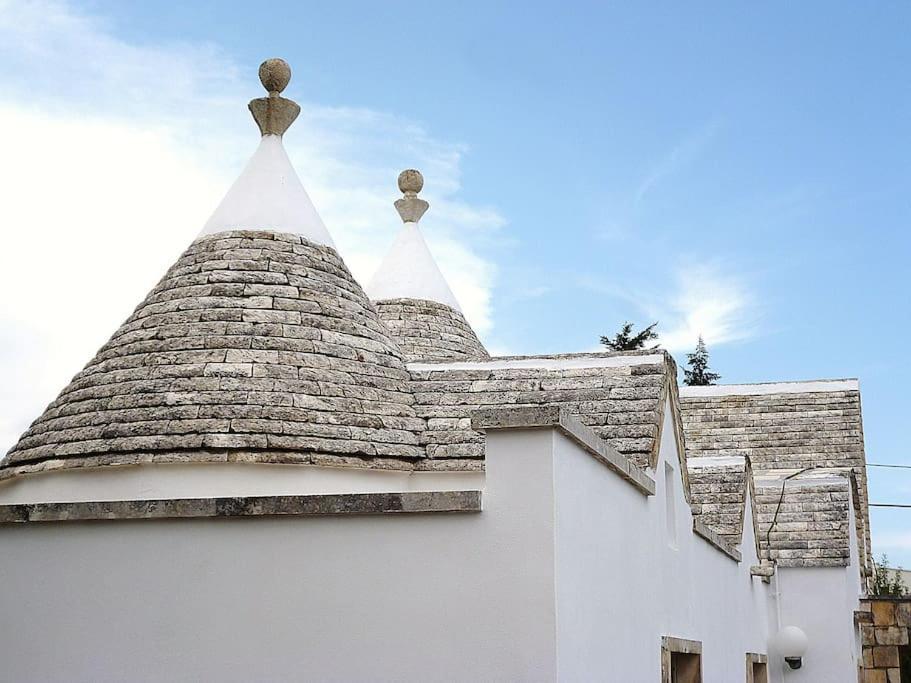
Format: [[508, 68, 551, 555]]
[[367, 169, 489, 362]]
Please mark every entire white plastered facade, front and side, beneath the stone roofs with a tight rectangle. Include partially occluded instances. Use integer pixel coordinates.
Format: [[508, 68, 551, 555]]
[[0, 398, 860, 683]]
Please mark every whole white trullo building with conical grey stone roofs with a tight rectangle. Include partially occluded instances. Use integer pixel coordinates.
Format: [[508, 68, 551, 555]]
[[0, 60, 884, 683]]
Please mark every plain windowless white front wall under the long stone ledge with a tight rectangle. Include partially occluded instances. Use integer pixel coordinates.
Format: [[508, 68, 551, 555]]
[[0, 432, 556, 681]]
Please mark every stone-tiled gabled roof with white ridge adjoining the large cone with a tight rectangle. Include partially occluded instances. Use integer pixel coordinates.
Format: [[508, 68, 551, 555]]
[[409, 351, 676, 468]]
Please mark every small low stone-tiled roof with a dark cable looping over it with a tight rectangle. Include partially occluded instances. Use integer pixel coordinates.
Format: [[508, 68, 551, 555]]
[[754, 469, 854, 567]]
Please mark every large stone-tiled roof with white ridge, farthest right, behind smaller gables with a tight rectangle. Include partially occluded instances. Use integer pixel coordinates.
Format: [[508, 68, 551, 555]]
[[680, 379, 870, 563]]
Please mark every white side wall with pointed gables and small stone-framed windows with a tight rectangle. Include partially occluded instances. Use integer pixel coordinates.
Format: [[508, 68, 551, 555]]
[[555, 398, 768, 681]]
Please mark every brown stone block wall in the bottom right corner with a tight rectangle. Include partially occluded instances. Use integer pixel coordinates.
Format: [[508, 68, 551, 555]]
[[857, 597, 911, 683]]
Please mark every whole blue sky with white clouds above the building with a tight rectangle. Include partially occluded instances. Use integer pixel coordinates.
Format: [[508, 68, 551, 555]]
[[0, 0, 911, 566]]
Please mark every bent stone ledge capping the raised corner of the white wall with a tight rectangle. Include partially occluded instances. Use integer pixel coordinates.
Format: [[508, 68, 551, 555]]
[[471, 406, 655, 496]]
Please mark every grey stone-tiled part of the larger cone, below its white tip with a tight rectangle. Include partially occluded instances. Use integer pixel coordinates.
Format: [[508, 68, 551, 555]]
[[2, 231, 426, 476]]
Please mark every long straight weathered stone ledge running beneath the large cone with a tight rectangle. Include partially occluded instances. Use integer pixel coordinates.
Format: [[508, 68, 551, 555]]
[[0, 491, 481, 524]]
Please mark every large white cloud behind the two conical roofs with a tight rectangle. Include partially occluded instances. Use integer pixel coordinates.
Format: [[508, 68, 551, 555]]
[[0, 0, 503, 451]]
